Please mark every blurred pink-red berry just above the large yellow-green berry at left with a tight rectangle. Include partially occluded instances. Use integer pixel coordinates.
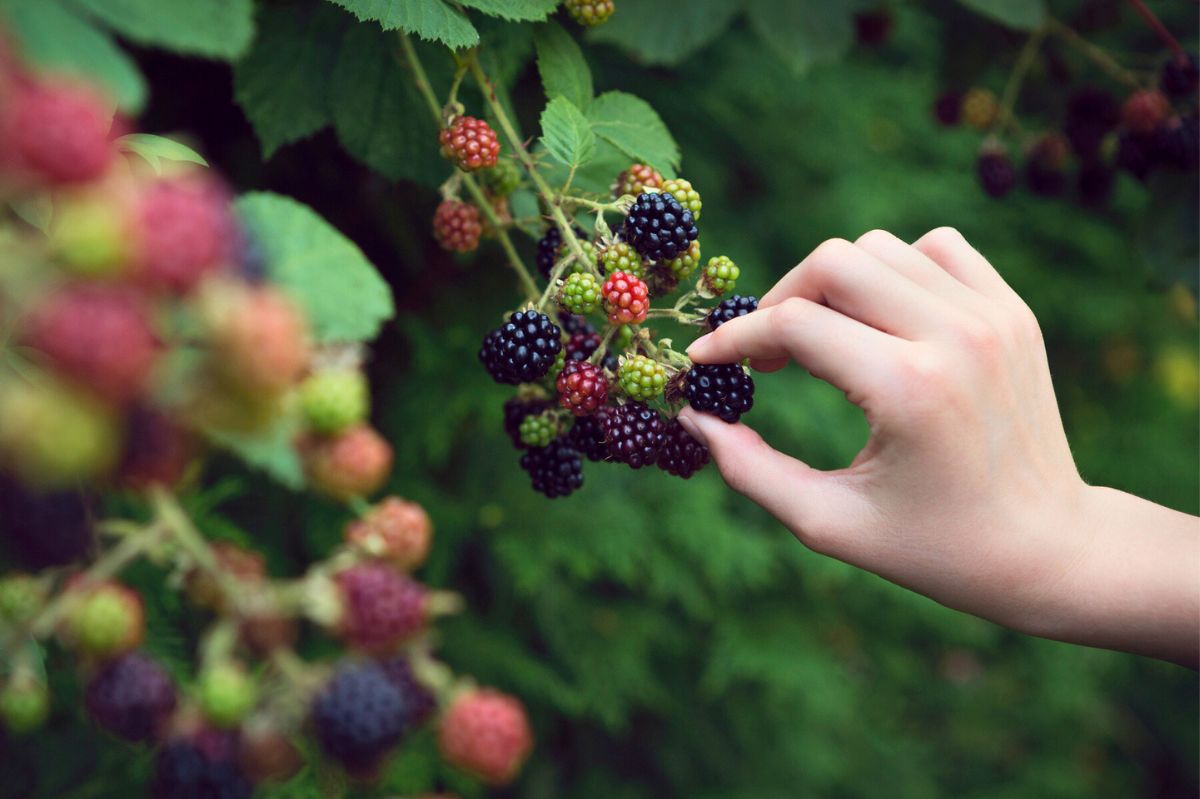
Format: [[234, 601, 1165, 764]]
[[25, 284, 158, 402]]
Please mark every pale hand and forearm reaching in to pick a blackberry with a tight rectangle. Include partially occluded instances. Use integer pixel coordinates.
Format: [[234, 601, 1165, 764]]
[[680, 228, 1200, 668]]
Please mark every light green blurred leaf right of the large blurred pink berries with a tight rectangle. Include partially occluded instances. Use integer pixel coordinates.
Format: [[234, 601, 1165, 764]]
[[236, 192, 394, 342]]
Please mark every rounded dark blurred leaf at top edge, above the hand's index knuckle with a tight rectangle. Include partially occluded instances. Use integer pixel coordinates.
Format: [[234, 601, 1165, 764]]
[[748, 0, 854, 72]]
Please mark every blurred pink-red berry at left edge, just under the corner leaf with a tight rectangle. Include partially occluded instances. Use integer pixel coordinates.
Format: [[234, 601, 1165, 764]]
[[0, 83, 116, 184]]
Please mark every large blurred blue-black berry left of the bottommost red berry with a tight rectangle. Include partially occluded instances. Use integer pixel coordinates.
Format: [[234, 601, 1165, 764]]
[[312, 663, 409, 770]]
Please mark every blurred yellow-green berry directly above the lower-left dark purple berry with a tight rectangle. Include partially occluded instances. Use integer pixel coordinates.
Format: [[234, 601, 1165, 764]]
[[64, 582, 145, 659]]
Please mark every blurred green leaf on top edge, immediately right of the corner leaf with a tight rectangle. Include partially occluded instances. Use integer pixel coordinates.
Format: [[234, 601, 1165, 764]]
[[70, 0, 254, 61]]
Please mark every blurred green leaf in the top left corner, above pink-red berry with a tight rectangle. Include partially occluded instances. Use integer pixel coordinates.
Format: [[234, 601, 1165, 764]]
[[0, 0, 146, 114]]
